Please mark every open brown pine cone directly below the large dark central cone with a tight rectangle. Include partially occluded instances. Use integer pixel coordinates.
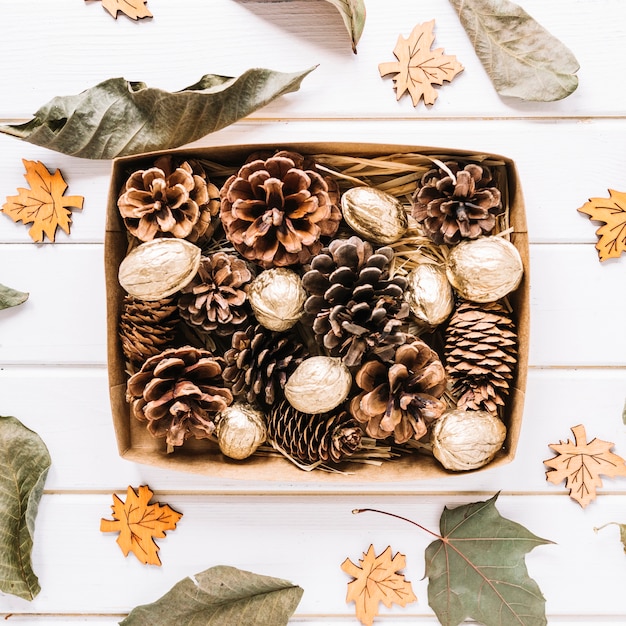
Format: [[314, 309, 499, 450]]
[[350, 339, 446, 443]]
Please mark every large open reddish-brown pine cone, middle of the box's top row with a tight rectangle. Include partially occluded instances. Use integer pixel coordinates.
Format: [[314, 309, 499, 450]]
[[220, 152, 341, 268]]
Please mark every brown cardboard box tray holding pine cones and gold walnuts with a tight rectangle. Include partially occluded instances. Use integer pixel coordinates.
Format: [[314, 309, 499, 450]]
[[104, 143, 530, 486]]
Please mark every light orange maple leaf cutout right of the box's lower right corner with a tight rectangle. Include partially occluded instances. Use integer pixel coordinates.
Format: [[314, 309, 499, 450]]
[[544, 424, 626, 508]]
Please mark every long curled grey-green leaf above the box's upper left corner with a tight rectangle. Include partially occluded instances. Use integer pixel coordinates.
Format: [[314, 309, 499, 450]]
[[0, 68, 315, 159]]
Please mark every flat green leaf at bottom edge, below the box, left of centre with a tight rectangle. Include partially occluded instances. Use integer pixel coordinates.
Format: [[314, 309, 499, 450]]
[[120, 565, 303, 626]]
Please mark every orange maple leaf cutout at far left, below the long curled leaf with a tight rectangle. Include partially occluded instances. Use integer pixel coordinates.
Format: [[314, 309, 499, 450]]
[[1, 159, 84, 243]]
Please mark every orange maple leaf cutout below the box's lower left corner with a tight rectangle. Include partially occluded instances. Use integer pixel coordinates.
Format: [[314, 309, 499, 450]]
[[100, 485, 182, 565]]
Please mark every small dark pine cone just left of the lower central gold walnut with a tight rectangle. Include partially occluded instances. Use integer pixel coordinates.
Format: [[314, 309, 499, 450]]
[[224, 324, 306, 406]]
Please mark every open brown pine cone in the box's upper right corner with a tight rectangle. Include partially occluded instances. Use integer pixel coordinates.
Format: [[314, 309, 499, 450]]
[[412, 161, 502, 244]]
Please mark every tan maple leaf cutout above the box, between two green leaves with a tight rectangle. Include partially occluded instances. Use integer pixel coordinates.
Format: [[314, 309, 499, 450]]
[[378, 20, 464, 106]]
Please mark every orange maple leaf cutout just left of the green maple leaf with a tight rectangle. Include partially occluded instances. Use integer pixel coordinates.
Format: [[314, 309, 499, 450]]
[[341, 545, 417, 626]]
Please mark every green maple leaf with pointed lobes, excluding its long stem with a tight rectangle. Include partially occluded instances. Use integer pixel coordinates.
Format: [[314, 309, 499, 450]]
[[426, 495, 552, 626]]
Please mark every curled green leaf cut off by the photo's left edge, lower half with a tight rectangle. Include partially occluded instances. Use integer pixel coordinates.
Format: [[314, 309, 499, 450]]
[[0, 416, 50, 600]]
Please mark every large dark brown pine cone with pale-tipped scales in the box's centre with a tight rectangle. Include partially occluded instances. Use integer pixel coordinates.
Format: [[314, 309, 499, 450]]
[[302, 237, 409, 367]]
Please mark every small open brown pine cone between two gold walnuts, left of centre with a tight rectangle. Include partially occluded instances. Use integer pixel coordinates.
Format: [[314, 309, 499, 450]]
[[178, 252, 252, 336]]
